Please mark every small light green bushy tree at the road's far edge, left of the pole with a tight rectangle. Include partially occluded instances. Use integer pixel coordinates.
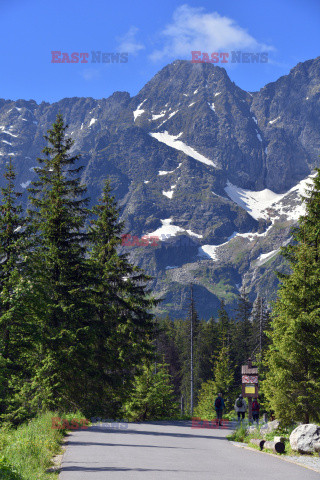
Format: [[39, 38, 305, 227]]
[[124, 364, 178, 421]]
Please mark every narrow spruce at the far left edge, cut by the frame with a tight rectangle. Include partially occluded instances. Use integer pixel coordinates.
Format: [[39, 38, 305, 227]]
[[0, 158, 28, 418]]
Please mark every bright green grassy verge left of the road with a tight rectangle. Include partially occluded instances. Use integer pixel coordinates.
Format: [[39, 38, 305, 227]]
[[0, 412, 83, 480]]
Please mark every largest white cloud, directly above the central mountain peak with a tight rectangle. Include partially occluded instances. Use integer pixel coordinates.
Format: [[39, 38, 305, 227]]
[[150, 5, 273, 61]]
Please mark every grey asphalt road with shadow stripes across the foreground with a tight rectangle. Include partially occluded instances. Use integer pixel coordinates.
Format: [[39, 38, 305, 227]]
[[59, 422, 319, 480]]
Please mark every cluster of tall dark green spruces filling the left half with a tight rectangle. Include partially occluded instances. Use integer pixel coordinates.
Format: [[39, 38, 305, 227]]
[[0, 115, 157, 425]]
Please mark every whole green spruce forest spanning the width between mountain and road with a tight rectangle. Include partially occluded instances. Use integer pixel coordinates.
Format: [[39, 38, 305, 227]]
[[0, 115, 320, 425]]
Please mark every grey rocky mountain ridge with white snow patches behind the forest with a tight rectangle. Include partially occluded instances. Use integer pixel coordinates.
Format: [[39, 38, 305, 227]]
[[0, 57, 320, 318]]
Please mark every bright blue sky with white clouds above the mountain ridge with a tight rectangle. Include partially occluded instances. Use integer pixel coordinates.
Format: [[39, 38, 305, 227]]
[[0, 0, 320, 103]]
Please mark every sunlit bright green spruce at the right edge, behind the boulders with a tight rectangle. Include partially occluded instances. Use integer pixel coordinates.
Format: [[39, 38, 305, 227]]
[[263, 169, 320, 423]]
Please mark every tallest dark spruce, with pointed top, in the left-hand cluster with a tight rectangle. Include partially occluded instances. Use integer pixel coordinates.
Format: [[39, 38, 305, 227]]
[[28, 115, 89, 409]]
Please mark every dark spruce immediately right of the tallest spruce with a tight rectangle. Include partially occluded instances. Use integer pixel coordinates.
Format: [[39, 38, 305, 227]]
[[89, 181, 158, 411]]
